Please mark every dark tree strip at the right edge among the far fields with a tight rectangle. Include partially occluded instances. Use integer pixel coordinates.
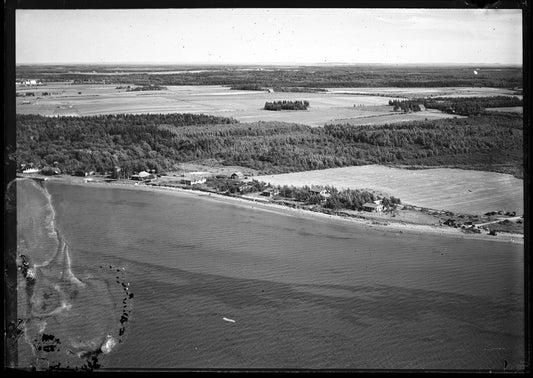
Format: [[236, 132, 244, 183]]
[[423, 96, 524, 116]]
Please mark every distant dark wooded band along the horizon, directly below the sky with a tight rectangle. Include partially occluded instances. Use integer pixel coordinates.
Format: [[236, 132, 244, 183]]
[[17, 65, 523, 88]]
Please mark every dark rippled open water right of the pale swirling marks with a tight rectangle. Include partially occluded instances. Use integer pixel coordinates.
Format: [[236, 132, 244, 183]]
[[16, 182, 524, 369]]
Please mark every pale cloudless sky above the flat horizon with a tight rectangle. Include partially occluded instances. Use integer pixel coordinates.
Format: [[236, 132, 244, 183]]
[[15, 8, 522, 64]]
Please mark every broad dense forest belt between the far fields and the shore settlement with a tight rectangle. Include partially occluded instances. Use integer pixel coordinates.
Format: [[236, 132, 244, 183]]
[[16, 114, 523, 177]]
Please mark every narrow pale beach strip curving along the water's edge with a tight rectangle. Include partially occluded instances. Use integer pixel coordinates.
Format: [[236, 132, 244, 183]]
[[20, 176, 524, 245]]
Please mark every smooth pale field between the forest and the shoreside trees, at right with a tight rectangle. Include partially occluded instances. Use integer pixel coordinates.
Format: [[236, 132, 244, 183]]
[[253, 165, 524, 215]]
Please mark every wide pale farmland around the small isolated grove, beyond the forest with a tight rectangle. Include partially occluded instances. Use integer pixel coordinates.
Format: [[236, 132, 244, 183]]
[[16, 83, 507, 126]]
